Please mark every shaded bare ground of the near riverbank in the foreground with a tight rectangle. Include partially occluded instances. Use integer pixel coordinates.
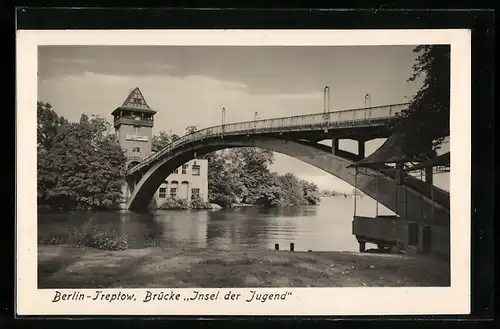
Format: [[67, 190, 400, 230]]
[[38, 245, 450, 289]]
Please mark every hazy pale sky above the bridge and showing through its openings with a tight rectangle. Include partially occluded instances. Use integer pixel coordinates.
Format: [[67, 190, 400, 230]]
[[38, 46, 448, 192]]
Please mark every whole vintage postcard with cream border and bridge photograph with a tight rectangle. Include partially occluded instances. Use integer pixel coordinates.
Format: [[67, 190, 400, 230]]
[[16, 30, 471, 316]]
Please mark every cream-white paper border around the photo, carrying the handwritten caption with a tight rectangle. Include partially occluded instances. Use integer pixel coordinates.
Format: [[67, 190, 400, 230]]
[[15, 30, 471, 315]]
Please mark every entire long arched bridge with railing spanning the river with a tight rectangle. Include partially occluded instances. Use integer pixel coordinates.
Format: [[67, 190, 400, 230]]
[[125, 103, 450, 226]]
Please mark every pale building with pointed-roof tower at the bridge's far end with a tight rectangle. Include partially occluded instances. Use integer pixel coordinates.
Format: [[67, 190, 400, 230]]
[[112, 87, 208, 206]]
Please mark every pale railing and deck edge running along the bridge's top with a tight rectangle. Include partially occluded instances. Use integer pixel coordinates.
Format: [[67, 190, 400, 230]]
[[127, 103, 409, 173]]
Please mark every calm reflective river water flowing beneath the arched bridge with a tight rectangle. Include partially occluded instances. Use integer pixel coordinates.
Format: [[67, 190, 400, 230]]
[[38, 196, 390, 251]]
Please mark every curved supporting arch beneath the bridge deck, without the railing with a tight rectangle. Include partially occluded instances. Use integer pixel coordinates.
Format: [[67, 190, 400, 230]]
[[126, 137, 449, 225]]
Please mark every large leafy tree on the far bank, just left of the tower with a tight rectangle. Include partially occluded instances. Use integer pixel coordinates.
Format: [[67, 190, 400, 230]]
[[38, 103, 125, 209]]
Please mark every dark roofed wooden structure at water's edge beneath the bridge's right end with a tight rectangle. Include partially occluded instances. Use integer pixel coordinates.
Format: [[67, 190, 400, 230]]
[[352, 134, 450, 257]]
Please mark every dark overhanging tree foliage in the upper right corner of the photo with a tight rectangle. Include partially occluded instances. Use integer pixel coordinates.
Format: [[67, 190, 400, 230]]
[[397, 45, 450, 157]]
